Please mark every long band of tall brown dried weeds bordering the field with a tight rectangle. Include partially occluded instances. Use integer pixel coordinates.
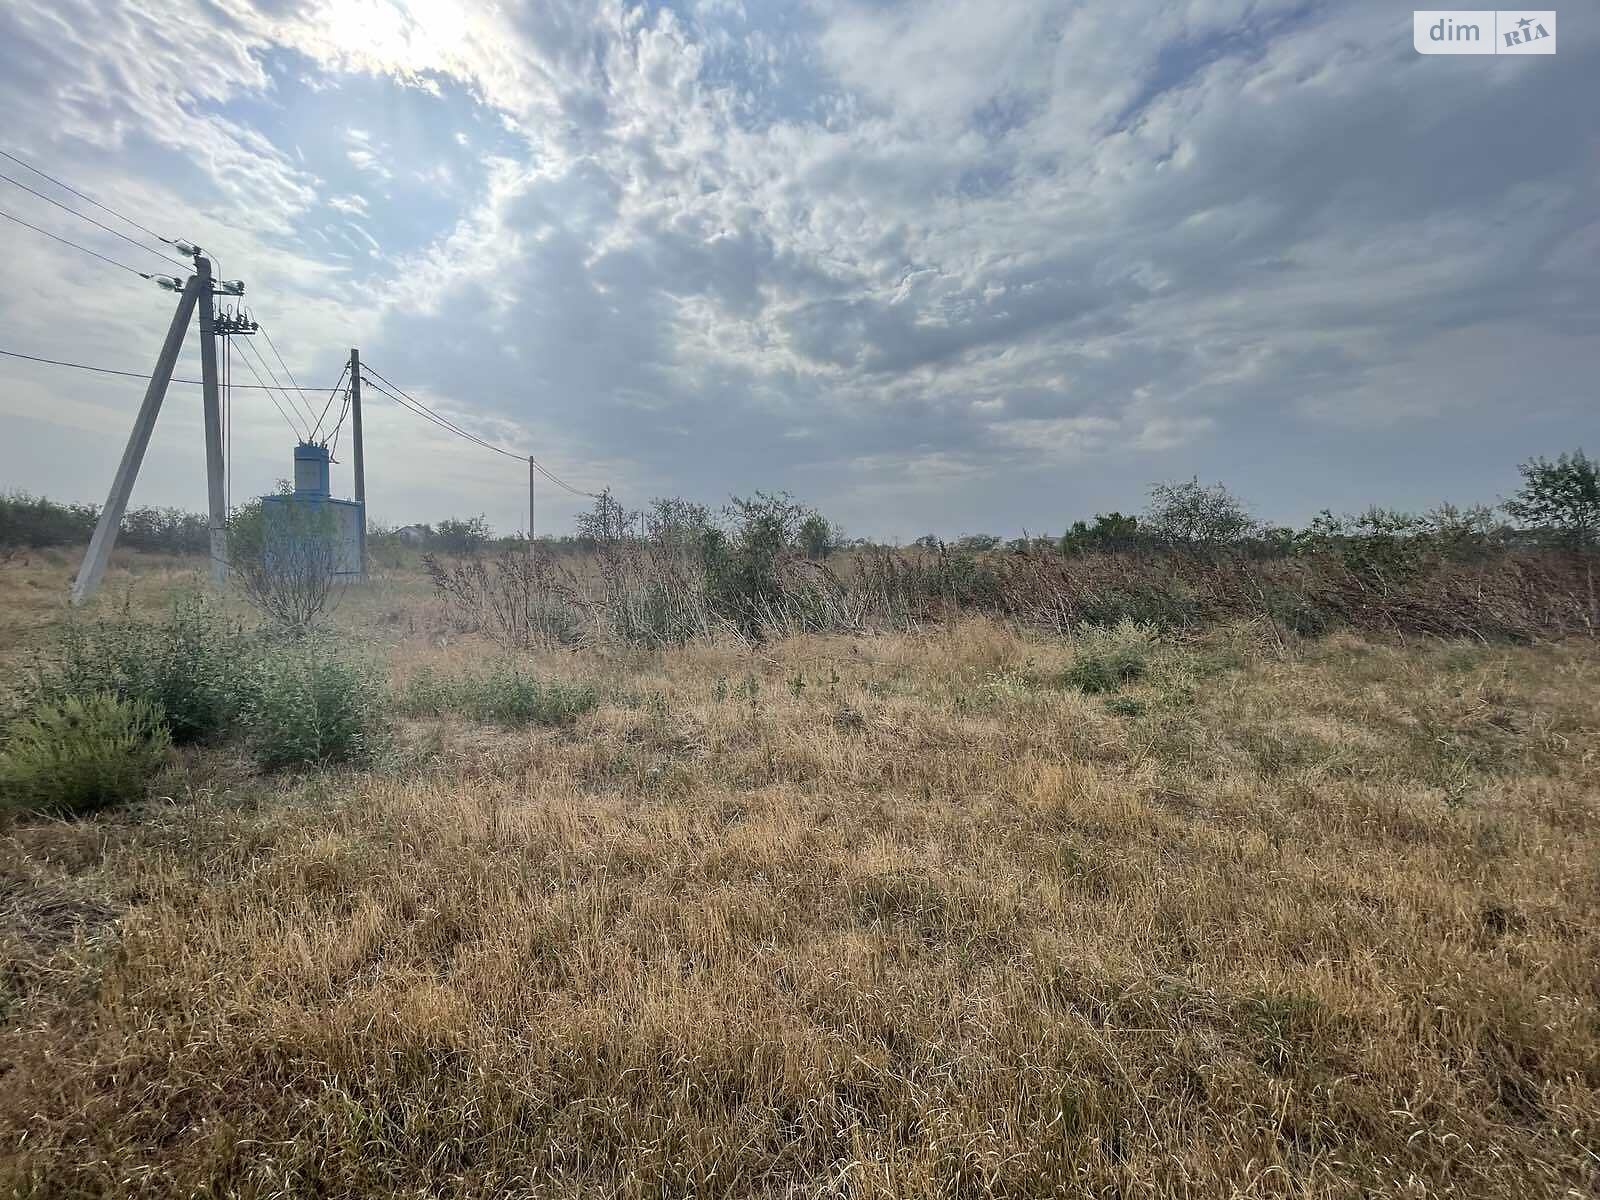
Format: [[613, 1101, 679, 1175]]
[[429, 538, 1600, 646]]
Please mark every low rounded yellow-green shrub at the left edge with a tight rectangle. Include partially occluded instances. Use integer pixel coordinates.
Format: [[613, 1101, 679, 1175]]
[[0, 693, 171, 816]]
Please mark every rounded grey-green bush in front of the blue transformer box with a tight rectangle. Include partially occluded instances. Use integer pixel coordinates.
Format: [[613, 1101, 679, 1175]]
[[245, 649, 386, 770]]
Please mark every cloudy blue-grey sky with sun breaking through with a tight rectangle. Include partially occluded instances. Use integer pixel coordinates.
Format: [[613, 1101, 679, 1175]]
[[0, 0, 1600, 539]]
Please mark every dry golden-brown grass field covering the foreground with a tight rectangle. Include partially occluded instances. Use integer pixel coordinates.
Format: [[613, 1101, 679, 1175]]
[[0, 558, 1600, 1198]]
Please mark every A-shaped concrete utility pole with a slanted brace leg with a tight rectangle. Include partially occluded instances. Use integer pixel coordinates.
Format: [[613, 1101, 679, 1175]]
[[72, 242, 245, 605]]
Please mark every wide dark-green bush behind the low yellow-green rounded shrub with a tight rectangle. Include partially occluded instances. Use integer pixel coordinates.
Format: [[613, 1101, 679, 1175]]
[[22, 594, 262, 744]]
